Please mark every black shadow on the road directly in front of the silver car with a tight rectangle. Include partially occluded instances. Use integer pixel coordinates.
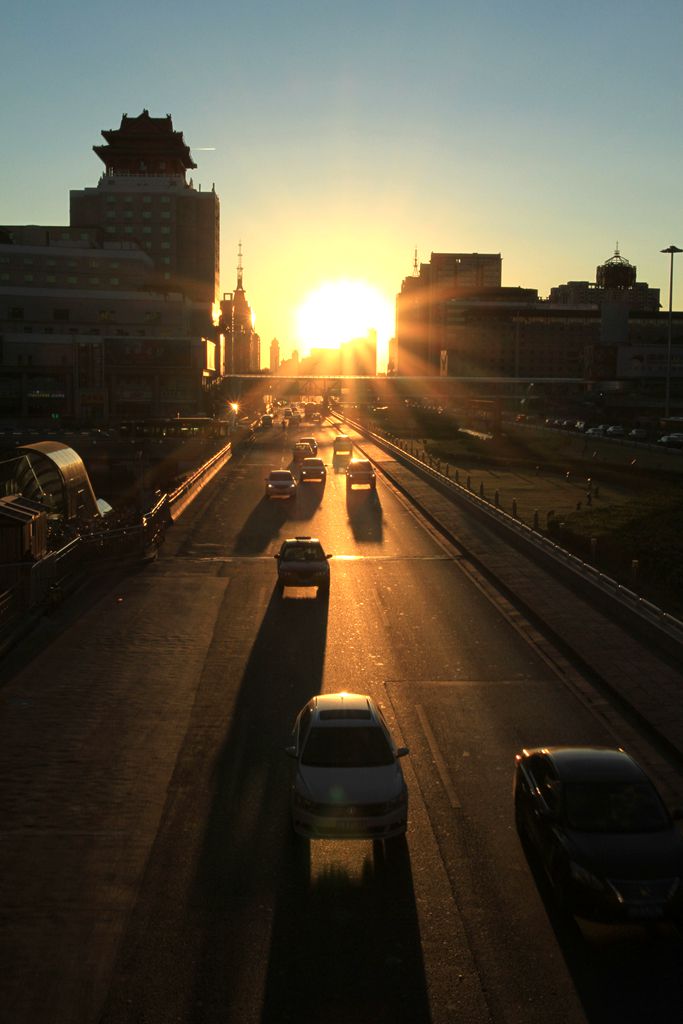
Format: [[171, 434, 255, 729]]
[[261, 840, 430, 1024]]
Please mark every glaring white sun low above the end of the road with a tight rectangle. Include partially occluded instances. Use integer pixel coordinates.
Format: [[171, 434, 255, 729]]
[[296, 280, 394, 354]]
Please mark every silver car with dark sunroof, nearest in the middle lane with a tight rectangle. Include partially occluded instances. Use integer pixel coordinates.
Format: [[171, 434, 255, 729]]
[[287, 692, 409, 840]]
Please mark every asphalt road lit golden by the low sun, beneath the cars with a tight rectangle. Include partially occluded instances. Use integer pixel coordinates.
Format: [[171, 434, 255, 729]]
[[0, 419, 683, 1024]]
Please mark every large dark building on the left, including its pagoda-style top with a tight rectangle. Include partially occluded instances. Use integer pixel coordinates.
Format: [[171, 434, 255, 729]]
[[0, 112, 221, 424]]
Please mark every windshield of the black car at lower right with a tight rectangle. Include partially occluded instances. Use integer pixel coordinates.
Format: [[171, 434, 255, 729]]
[[564, 782, 670, 833]]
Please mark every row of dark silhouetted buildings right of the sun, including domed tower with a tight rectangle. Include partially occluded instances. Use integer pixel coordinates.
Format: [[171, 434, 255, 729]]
[[396, 250, 683, 403]]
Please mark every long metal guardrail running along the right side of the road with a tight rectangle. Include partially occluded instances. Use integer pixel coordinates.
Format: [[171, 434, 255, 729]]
[[337, 414, 683, 645]]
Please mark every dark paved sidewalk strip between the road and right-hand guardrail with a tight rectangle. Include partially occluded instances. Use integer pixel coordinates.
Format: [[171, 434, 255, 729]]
[[358, 439, 683, 805]]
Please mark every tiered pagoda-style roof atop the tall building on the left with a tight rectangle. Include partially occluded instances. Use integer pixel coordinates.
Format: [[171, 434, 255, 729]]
[[92, 110, 197, 176]]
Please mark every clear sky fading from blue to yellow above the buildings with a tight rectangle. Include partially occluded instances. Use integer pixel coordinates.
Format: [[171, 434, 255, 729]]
[[0, 0, 683, 369]]
